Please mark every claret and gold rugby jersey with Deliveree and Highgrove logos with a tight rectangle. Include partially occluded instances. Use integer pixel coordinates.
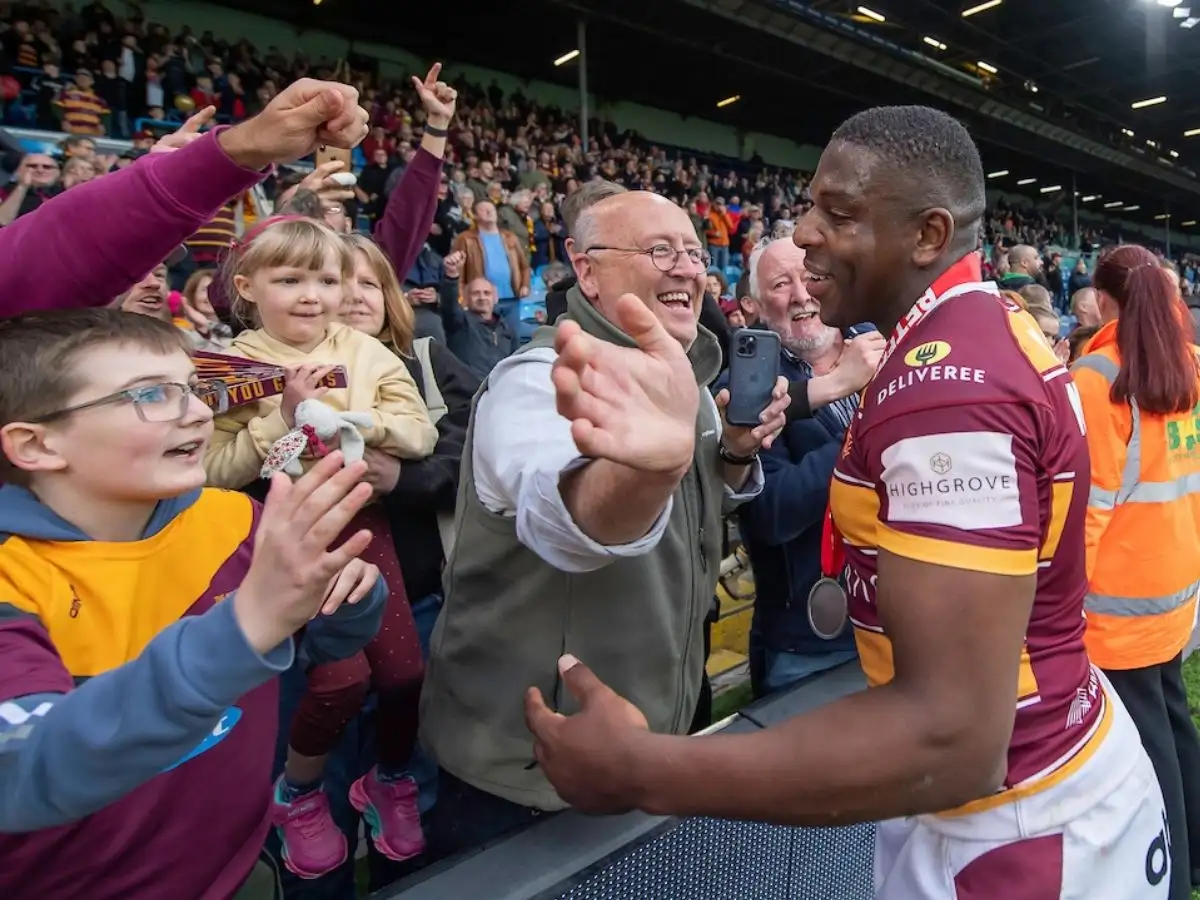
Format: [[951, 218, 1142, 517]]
[[830, 257, 1110, 811]]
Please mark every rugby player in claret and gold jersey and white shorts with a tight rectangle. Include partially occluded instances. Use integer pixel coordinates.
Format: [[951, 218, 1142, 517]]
[[526, 107, 1170, 900]]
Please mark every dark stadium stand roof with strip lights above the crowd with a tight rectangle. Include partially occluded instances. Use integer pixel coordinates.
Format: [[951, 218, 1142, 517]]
[[226, 0, 1200, 232]]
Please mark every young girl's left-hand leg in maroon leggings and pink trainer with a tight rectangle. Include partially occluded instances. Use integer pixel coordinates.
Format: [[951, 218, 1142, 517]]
[[272, 653, 371, 878]]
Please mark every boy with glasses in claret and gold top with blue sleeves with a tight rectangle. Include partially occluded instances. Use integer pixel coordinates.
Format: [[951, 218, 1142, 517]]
[[0, 310, 386, 900]]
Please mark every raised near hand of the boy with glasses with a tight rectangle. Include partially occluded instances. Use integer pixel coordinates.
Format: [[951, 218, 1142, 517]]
[[233, 451, 373, 654]]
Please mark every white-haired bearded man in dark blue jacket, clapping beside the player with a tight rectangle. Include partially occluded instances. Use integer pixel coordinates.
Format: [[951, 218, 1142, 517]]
[[724, 238, 884, 696]]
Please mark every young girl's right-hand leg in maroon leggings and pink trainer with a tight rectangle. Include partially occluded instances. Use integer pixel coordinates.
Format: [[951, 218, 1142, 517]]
[[350, 508, 425, 860]]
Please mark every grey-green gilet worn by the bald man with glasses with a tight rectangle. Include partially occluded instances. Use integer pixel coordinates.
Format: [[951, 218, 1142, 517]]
[[421, 287, 725, 810]]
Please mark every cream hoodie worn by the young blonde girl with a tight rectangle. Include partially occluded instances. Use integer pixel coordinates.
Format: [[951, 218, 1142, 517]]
[[204, 323, 438, 490]]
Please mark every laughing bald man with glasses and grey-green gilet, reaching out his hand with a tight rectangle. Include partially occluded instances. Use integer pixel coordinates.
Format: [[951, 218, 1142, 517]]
[[421, 184, 787, 853]]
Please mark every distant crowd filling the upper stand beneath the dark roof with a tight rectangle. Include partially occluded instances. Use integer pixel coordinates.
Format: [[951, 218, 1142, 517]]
[[0, 0, 1142, 305]]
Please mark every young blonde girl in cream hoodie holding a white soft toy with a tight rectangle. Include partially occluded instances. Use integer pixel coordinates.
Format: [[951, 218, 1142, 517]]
[[205, 216, 437, 878]]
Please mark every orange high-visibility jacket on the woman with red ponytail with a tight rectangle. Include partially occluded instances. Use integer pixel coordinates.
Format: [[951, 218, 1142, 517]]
[[1070, 322, 1200, 670]]
